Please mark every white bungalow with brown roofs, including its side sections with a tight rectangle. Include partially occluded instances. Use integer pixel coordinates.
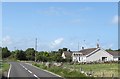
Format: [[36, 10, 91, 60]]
[[62, 47, 120, 62]]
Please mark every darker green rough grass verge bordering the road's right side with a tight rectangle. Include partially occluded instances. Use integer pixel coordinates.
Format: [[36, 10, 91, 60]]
[[33, 63, 89, 79]]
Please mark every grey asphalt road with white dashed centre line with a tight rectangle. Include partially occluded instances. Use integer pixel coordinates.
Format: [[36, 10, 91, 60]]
[[8, 62, 63, 79]]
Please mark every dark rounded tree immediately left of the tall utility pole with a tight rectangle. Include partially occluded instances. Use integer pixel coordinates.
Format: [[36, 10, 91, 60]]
[[25, 48, 35, 61]]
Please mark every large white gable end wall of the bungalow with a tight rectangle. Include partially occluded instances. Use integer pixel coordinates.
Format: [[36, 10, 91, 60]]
[[86, 49, 113, 62]]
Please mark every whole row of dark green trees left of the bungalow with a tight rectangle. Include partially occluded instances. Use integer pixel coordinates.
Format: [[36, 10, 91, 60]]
[[0, 47, 72, 62]]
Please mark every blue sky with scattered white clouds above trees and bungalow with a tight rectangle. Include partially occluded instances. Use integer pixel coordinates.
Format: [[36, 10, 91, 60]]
[[2, 2, 118, 51]]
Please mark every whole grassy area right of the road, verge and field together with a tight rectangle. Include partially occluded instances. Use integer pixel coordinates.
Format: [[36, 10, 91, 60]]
[[33, 63, 118, 78]]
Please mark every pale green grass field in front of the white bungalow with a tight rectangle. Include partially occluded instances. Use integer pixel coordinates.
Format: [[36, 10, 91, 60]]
[[63, 63, 118, 77]]
